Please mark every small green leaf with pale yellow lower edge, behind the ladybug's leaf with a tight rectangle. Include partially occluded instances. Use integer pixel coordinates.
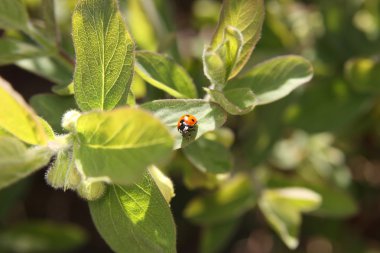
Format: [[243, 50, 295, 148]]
[[135, 51, 197, 98]]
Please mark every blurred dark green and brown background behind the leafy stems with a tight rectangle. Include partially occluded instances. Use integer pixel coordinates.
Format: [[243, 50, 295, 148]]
[[0, 0, 380, 253]]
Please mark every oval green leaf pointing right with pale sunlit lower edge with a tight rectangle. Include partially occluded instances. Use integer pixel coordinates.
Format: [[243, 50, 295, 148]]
[[225, 55, 313, 105]]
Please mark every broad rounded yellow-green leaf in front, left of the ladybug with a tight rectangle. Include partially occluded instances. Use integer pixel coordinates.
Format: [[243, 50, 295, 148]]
[[74, 107, 173, 184]]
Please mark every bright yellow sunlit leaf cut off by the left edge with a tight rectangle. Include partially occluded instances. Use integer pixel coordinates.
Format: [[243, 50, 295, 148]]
[[0, 78, 47, 144]]
